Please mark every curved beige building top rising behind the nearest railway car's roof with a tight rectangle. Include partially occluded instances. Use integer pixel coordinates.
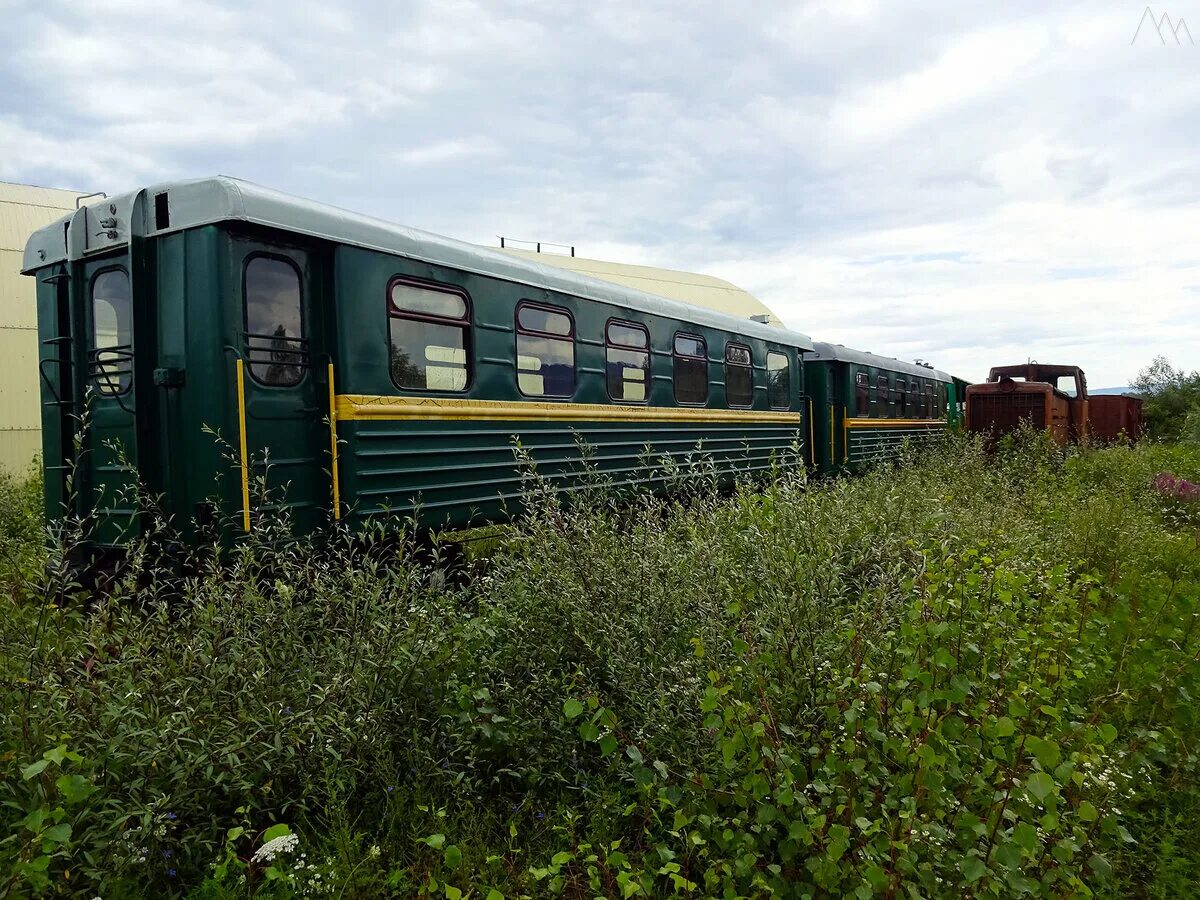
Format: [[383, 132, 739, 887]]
[[503, 247, 782, 326]]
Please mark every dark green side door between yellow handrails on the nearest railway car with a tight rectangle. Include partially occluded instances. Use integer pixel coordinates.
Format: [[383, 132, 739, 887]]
[[229, 236, 330, 533]]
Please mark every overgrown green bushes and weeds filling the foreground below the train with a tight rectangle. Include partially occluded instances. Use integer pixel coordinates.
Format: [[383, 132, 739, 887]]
[[0, 439, 1200, 900]]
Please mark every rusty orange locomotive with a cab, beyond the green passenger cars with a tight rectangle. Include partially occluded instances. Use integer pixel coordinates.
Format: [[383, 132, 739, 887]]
[[966, 362, 1088, 444]]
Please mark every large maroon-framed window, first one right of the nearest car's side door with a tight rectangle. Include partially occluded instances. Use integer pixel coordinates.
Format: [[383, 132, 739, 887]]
[[388, 281, 470, 391]]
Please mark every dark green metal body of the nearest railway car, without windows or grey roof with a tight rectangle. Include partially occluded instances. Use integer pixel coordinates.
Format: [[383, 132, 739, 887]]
[[31, 183, 809, 547]]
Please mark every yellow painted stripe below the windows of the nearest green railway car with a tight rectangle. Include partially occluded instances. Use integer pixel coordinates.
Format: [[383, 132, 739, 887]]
[[337, 394, 804, 427]]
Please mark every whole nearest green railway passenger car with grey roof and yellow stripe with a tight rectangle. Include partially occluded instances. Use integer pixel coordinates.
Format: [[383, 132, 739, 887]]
[[23, 178, 820, 547]]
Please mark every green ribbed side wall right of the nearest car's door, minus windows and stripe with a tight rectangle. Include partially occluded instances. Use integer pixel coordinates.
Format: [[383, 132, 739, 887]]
[[334, 247, 808, 524]]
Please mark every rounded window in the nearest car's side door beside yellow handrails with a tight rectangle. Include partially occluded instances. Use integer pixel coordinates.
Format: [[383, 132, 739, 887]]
[[242, 256, 306, 388]]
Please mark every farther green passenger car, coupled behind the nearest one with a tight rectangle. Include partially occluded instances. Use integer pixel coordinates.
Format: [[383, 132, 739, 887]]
[[804, 341, 962, 473]]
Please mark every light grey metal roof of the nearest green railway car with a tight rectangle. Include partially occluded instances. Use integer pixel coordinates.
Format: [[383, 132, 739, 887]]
[[22, 175, 814, 352]]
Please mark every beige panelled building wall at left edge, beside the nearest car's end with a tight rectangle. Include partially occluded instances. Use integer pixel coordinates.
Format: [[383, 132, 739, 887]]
[[0, 181, 79, 472]]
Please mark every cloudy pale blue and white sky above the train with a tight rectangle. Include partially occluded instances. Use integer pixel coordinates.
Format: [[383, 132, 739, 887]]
[[0, 0, 1200, 386]]
